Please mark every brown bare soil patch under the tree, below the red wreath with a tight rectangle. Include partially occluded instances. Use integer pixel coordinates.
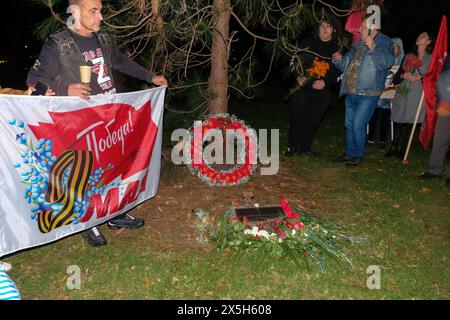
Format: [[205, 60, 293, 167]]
[[123, 156, 344, 250]]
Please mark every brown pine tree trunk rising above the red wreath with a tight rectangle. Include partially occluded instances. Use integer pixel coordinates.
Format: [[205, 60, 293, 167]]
[[208, 0, 231, 114]]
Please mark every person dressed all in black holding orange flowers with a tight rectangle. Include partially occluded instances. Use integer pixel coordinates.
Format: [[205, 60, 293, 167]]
[[285, 20, 339, 157]]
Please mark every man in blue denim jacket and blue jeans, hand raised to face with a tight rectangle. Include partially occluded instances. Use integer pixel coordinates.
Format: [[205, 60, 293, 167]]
[[333, 19, 395, 167]]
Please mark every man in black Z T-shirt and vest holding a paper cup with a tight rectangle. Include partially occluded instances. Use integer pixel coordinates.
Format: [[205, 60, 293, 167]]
[[27, 0, 167, 246]]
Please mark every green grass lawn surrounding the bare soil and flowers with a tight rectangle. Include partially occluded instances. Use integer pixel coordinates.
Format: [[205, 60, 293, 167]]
[[5, 84, 450, 299]]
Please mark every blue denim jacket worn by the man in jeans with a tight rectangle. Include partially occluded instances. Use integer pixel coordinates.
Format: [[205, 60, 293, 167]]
[[333, 33, 395, 96]]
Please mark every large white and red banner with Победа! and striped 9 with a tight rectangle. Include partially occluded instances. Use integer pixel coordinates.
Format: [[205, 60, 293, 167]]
[[0, 87, 166, 257]]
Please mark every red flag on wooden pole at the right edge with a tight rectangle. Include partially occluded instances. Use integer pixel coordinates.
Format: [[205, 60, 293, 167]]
[[419, 16, 448, 150]]
